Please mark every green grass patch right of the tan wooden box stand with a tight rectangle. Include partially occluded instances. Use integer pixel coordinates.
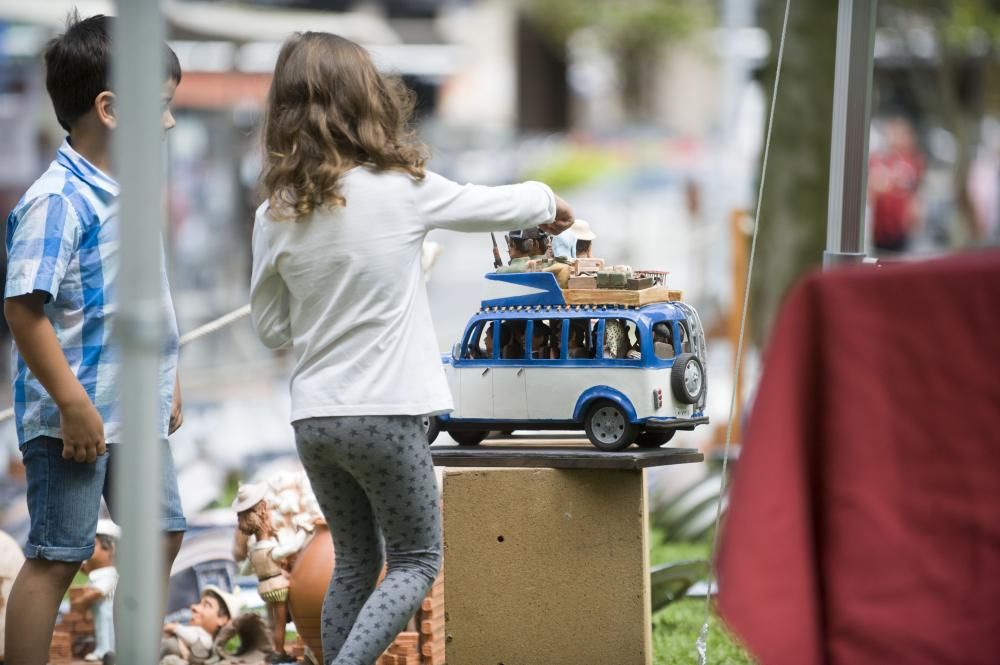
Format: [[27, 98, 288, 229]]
[[650, 529, 754, 665]]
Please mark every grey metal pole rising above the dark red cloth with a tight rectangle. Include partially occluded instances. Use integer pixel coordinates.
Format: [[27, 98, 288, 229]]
[[823, 0, 878, 267]]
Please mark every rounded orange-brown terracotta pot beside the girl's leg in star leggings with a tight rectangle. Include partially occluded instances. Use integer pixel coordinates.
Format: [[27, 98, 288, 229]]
[[288, 525, 333, 658]]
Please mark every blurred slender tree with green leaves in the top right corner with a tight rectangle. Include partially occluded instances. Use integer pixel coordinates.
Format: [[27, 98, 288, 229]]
[[879, 0, 1000, 245]]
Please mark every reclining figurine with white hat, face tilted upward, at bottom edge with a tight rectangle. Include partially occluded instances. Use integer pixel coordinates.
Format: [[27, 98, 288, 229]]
[[160, 584, 240, 665]]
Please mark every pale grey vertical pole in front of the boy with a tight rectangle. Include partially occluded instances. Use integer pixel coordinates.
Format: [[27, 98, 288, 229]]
[[113, 0, 165, 665]]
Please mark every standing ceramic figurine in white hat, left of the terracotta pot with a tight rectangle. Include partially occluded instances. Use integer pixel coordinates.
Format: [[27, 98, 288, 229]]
[[233, 483, 302, 662]]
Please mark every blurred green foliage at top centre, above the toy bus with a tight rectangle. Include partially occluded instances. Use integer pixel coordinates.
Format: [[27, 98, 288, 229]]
[[524, 0, 711, 51]]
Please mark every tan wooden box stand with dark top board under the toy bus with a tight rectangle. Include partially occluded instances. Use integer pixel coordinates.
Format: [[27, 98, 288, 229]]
[[431, 444, 701, 665]]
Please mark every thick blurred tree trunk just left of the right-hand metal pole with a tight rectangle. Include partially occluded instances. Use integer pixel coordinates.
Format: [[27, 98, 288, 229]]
[[750, 0, 837, 345]]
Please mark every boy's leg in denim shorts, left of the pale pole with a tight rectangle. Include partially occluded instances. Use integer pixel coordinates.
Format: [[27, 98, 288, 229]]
[[5, 437, 108, 665]]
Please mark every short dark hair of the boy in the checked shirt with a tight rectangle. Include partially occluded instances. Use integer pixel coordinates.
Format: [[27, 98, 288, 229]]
[[45, 11, 181, 132]]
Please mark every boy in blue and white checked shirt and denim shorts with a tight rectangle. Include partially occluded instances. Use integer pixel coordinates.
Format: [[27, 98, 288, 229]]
[[4, 16, 186, 665]]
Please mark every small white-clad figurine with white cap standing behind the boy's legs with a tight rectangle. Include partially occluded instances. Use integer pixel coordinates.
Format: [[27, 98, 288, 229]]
[[73, 520, 121, 663]]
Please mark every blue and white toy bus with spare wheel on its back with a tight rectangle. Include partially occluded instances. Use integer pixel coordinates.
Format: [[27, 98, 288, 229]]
[[427, 272, 708, 451]]
